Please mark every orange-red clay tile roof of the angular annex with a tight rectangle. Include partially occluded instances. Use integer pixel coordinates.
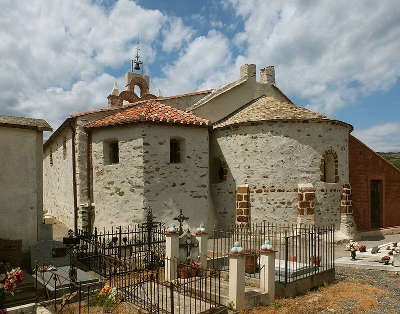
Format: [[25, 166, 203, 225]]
[[86, 100, 209, 128]]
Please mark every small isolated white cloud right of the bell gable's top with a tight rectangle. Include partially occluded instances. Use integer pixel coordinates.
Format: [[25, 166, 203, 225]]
[[162, 17, 194, 52]]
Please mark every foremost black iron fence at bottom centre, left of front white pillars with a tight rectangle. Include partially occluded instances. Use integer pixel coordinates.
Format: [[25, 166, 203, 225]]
[[109, 258, 221, 313]]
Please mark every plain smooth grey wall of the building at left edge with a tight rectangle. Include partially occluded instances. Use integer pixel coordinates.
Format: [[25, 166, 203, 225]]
[[0, 127, 43, 251]]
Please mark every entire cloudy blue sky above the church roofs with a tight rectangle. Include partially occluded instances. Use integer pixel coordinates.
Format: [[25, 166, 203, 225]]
[[0, 0, 400, 151]]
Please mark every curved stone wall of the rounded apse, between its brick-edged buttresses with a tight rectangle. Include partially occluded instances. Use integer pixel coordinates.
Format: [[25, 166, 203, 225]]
[[211, 122, 349, 226]]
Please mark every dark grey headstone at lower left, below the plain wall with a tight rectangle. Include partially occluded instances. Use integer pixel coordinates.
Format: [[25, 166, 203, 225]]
[[31, 240, 69, 267]]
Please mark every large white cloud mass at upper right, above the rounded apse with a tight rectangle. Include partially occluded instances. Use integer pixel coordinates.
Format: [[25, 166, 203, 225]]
[[228, 0, 400, 113]]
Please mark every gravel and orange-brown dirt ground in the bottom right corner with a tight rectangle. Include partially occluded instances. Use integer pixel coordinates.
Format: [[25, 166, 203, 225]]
[[249, 267, 400, 314]]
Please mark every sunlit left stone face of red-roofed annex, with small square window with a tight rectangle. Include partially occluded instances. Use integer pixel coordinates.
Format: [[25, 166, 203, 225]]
[[92, 126, 144, 229]]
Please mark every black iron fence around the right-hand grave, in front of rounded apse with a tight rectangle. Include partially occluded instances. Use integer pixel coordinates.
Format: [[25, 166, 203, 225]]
[[208, 222, 334, 283]]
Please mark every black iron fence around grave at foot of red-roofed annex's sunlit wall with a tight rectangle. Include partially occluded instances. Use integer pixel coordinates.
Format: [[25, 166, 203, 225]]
[[74, 223, 165, 277]]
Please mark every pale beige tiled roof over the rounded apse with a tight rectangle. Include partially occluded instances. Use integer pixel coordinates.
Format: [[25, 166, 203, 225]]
[[214, 96, 352, 128]]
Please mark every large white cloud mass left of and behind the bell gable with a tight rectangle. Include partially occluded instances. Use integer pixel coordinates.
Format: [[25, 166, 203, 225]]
[[0, 0, 167, 128]]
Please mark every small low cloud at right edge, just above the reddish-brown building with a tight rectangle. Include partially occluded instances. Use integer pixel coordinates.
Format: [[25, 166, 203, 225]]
[[353, 123, 400, 152]]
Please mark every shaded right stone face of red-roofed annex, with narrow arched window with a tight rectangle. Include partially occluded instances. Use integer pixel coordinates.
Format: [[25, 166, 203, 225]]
[[143, 124, 214, 228]]
